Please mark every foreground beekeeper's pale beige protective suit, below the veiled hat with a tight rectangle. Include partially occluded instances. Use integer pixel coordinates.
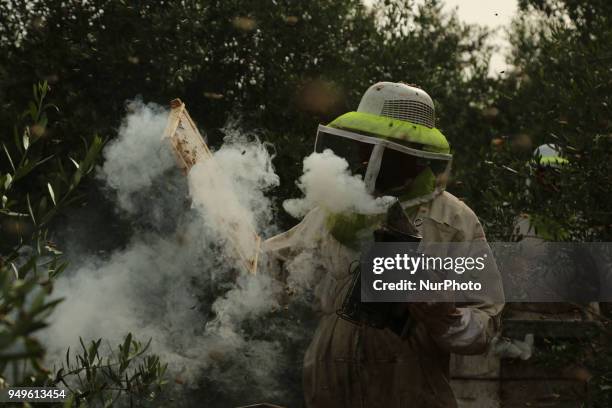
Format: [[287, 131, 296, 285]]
[[265, 192, 503, 408]]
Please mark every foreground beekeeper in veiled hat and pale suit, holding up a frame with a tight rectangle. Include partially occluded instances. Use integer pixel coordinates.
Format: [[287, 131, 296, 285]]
[[265, 82, 503, 408]]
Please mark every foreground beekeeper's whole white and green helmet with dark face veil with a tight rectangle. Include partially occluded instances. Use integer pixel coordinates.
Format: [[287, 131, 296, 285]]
[[315, 82, 452, 206]]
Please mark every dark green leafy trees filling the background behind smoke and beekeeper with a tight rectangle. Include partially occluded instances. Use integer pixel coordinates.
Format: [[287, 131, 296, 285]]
[[0, 0, 612, 406]]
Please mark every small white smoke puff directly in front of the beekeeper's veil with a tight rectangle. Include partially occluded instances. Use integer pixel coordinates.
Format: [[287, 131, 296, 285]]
[[283, 149, 394, 218]]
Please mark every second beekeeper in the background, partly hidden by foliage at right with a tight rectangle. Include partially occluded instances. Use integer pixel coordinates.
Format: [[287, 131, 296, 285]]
[[512, 144, 612, 310]]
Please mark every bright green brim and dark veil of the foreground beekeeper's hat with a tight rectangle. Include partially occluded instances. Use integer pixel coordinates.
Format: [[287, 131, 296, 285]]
[[315, 119, 452, 208]]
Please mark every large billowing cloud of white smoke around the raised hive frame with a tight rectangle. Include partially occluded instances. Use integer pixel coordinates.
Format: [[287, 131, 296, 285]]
[[44, 102, 290, 402]]
